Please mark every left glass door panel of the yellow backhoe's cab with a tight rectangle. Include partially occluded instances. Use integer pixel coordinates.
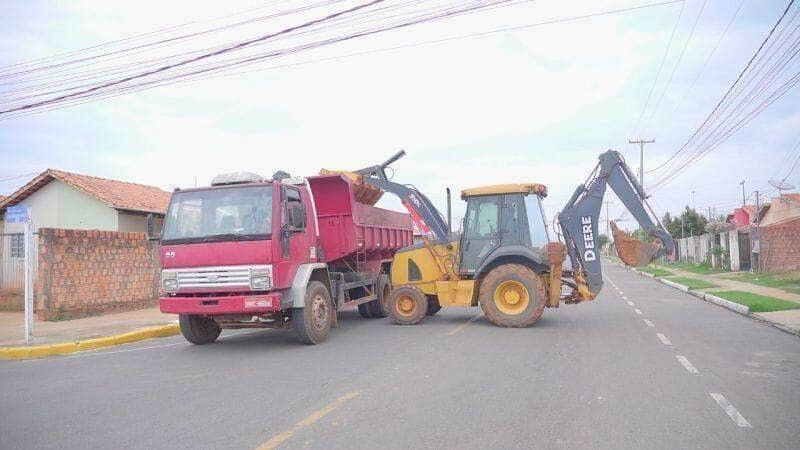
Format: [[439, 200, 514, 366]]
[[459, 195, 502, 273]]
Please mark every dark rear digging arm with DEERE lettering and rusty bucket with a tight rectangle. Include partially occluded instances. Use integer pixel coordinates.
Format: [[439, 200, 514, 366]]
[[558, 150, 674, 301]]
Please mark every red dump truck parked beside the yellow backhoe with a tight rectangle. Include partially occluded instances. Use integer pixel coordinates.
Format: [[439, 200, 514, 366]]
[[159, 173, 412, 344]]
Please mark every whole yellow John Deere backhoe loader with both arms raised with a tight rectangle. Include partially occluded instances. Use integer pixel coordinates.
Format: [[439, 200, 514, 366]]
[[355, 151, 673, 327]]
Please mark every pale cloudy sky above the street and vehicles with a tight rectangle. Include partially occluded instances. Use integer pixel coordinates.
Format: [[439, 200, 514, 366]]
[[0, 0, 800, 227]]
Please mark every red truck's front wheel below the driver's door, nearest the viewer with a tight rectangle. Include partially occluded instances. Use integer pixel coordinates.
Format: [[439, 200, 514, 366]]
[[292, 281, 334, 345]]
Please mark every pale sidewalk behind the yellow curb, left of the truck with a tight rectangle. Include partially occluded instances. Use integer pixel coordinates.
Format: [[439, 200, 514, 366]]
[[0, 306, 178, 347]]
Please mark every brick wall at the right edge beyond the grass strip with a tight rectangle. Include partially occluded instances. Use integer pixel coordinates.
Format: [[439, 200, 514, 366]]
[[759, 218, 800, 272]]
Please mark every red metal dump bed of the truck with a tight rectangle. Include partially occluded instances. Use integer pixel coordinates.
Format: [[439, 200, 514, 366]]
[[307, 174, 413, 262]]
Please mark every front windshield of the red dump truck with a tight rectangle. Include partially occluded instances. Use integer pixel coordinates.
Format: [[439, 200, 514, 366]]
[[162, 185, 272, 243]]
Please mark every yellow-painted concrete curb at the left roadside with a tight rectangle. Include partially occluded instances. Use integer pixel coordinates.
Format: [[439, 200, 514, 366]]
[[0, 323, 181, 359]]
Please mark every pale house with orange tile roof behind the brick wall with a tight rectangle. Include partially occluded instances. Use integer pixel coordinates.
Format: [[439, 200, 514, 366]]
[[0, 169, 171, 234]]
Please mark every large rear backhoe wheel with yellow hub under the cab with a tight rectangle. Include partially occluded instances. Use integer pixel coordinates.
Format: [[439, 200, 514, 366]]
[[479, 264, 547, 328]]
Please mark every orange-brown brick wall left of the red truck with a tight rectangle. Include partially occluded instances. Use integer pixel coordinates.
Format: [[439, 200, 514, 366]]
[[35, 228, 159, 320]]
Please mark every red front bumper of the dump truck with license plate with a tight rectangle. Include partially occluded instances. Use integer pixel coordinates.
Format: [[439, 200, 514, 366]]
[[158, 292, 281, 315]]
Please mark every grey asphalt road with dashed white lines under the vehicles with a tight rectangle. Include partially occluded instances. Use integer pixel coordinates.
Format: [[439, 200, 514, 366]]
[[0, 264, 800, 449]]
